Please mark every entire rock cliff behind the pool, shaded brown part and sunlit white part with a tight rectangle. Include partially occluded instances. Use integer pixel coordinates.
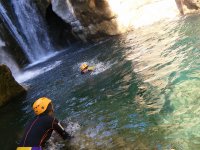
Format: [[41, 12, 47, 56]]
[[38, 0, 200, 40]]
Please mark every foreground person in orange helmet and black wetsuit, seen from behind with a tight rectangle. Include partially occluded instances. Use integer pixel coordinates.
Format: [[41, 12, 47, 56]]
[[17, 97, 72, 150]]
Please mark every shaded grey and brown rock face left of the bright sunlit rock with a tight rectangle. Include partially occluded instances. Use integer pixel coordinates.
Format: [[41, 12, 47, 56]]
[[51, 0, 121, 38]]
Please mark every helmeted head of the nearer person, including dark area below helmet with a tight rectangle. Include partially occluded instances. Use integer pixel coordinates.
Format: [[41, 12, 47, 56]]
[[33, 97, 54, 115]]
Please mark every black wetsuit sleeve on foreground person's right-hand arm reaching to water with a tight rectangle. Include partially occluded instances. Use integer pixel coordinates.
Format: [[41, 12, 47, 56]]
[[53, 119, 72, 140]]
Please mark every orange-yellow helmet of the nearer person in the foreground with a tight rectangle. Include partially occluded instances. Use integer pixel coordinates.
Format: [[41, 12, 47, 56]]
[[33, 97, 51, 115]]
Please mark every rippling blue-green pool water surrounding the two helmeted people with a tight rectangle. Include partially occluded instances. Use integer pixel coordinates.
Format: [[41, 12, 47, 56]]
[[0, 15, 200, 150]]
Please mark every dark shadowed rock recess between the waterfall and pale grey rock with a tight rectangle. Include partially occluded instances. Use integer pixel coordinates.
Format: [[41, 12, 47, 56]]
[[35, 0, 78, 47]]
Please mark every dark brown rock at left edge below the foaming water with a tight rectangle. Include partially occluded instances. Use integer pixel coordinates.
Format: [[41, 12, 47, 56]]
[[0, 65, 26, 106]]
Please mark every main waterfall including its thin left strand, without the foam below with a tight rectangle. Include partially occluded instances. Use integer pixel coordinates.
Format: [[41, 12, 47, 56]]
[[0, 0, 53, 63]]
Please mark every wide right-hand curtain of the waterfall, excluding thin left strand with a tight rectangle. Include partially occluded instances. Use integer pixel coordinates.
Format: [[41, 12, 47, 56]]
[[11, 0, 52, 62]]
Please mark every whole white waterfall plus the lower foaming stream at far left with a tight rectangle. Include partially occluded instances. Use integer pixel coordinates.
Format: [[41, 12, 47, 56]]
[[0, 0, 61, 83]]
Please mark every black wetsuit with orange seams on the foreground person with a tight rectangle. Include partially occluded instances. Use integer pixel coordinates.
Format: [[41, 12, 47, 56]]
[[19, 115, 71, 147]]
